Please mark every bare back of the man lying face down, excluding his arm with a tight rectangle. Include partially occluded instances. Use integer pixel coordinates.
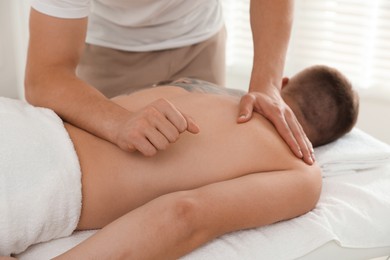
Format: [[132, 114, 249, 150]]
[[66, 86, 302, 229]]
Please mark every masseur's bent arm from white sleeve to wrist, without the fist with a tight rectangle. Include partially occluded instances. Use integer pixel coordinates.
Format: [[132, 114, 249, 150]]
[[25, 8, 130, 145]]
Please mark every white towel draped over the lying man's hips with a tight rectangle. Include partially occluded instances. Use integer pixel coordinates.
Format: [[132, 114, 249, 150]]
[[0, 97, 81, 255]]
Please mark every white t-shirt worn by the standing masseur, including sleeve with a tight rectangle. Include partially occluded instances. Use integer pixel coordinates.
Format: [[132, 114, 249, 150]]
[[31, 0, 223, 51]]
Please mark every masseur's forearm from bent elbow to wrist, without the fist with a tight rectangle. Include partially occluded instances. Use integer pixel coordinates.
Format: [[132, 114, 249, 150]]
[[26, 67, 131, 143]]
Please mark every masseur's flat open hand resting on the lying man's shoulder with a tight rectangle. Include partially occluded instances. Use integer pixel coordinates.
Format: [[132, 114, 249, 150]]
[[237, 92, 315, 165]]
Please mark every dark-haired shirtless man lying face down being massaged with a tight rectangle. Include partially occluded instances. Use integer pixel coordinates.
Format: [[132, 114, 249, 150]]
[[0, 66, 358, 259]]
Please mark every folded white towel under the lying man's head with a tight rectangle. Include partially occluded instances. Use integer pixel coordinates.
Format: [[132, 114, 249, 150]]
[[314, 128, 390, 177]]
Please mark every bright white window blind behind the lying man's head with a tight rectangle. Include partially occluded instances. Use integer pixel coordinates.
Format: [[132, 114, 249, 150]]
[[222, 0, 390, 91]]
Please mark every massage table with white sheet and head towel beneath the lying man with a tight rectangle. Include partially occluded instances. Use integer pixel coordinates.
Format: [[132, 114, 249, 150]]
[[17, 128, 390, 260]]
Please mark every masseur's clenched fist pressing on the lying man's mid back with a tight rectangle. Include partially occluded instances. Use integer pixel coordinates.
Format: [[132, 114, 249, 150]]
[[117, 98, 199, 156]]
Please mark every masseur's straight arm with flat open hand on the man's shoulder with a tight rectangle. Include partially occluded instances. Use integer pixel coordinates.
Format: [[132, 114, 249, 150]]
[[237, 0, 315, 164]]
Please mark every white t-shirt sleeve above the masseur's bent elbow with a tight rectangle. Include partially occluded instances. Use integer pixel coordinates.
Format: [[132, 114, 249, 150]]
[[31, 0, 91, 18]]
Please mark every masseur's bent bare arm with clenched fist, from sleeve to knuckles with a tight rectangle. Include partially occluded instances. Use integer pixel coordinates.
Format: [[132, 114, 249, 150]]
[[25, 9, 199, 156]]
